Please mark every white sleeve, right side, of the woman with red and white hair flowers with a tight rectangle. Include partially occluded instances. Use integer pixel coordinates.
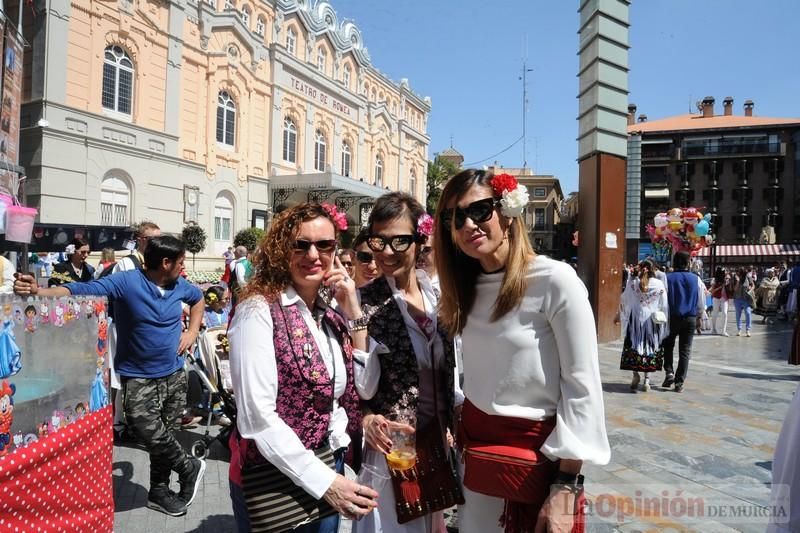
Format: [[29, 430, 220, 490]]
[[541, 269, 611, 465]]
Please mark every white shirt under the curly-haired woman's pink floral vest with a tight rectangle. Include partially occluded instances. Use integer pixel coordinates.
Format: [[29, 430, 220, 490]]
[[228, 287, 374, 499]]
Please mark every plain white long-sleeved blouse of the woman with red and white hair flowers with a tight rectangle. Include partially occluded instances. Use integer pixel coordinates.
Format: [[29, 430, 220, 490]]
[[462, 255, 611, 465]]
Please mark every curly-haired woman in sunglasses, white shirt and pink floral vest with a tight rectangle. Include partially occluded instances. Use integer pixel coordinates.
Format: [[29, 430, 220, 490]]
[[228, 204, 377, 533]]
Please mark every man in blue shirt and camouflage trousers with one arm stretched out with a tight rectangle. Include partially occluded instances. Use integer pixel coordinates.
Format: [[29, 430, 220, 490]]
[[14, 235, 205, 516]]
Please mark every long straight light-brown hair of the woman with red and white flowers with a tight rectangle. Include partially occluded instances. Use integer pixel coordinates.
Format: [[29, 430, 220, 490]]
[[433, 169, 536, 335]]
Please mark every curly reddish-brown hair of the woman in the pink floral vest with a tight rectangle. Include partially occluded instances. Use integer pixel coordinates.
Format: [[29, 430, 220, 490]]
[[242, 203, 339, 301]]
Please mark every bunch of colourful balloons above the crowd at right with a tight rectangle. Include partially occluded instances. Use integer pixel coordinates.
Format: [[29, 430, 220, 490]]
[[645, 207, 713, 262]]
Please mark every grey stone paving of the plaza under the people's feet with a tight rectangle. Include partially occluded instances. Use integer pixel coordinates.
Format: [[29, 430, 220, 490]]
[[114, 313, 800, 533]]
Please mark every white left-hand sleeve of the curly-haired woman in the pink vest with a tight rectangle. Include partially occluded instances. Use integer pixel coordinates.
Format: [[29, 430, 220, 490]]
[[228, 298, 336, 499]]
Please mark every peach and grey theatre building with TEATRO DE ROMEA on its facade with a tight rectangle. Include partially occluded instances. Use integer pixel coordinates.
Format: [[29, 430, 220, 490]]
[[15, 0, 431, 256]]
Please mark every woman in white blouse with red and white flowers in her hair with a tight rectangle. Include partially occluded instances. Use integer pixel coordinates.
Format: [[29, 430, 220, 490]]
[[434, 169, 610, 533]]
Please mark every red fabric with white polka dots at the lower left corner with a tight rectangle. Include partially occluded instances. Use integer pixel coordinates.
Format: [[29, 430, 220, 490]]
[[0, 406, 114, 533]]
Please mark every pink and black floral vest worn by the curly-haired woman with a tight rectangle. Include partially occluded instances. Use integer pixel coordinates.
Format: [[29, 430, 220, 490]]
[[239, 299, 361, 464]]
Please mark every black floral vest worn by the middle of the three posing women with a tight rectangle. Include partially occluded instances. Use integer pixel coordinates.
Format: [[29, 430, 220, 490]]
[[360, 278, 455, 428]]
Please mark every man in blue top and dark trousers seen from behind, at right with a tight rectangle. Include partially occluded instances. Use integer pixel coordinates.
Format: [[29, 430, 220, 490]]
[[661, 251, 705, 392]]
